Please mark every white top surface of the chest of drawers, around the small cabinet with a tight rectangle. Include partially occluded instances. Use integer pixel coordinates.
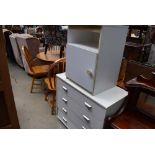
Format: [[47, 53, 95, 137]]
[[57, 73, 128, 109]]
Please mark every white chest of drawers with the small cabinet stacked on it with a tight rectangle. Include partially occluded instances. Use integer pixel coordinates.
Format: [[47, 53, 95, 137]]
[[56, 73, 127, 129]]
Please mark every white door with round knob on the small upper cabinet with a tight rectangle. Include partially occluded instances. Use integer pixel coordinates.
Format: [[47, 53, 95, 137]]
[[66, 45, 97, 93]]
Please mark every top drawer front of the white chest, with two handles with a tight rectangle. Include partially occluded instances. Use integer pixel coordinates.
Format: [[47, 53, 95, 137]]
[[57, 79, 106, 121]]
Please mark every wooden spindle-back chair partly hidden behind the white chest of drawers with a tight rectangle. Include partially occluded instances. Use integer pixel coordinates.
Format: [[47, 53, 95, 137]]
[[44, 58, 66, 114]]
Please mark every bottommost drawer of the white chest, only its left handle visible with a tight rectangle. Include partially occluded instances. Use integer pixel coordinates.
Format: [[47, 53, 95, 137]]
[[58, 109, 77, 129]]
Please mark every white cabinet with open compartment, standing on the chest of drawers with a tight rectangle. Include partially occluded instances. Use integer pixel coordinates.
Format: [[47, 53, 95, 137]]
[[66, 26, 128, 95]]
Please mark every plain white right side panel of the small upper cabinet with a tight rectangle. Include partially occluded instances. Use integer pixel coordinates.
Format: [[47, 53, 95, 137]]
[[94, 26, 128, 95]]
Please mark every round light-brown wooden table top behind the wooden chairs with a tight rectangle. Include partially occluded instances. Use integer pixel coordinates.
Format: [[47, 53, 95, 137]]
[[36, 51, 60, 62]]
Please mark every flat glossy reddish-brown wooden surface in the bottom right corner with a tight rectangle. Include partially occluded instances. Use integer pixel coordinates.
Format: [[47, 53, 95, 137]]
[[111, 111, 155, 129]]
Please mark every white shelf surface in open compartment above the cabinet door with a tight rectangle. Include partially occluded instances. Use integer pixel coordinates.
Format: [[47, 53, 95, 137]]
[[68, 42, 98, 53]]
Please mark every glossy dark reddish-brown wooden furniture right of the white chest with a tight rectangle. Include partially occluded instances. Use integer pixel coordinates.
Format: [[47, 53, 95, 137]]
[[105, 72, 155, 129]]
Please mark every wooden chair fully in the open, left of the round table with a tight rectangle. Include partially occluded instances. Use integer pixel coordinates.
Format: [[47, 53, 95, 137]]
[[22, 46, 49, 93]]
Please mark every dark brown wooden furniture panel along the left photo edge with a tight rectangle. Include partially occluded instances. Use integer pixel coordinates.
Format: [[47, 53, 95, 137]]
[[0, 26, 19, 129]]
